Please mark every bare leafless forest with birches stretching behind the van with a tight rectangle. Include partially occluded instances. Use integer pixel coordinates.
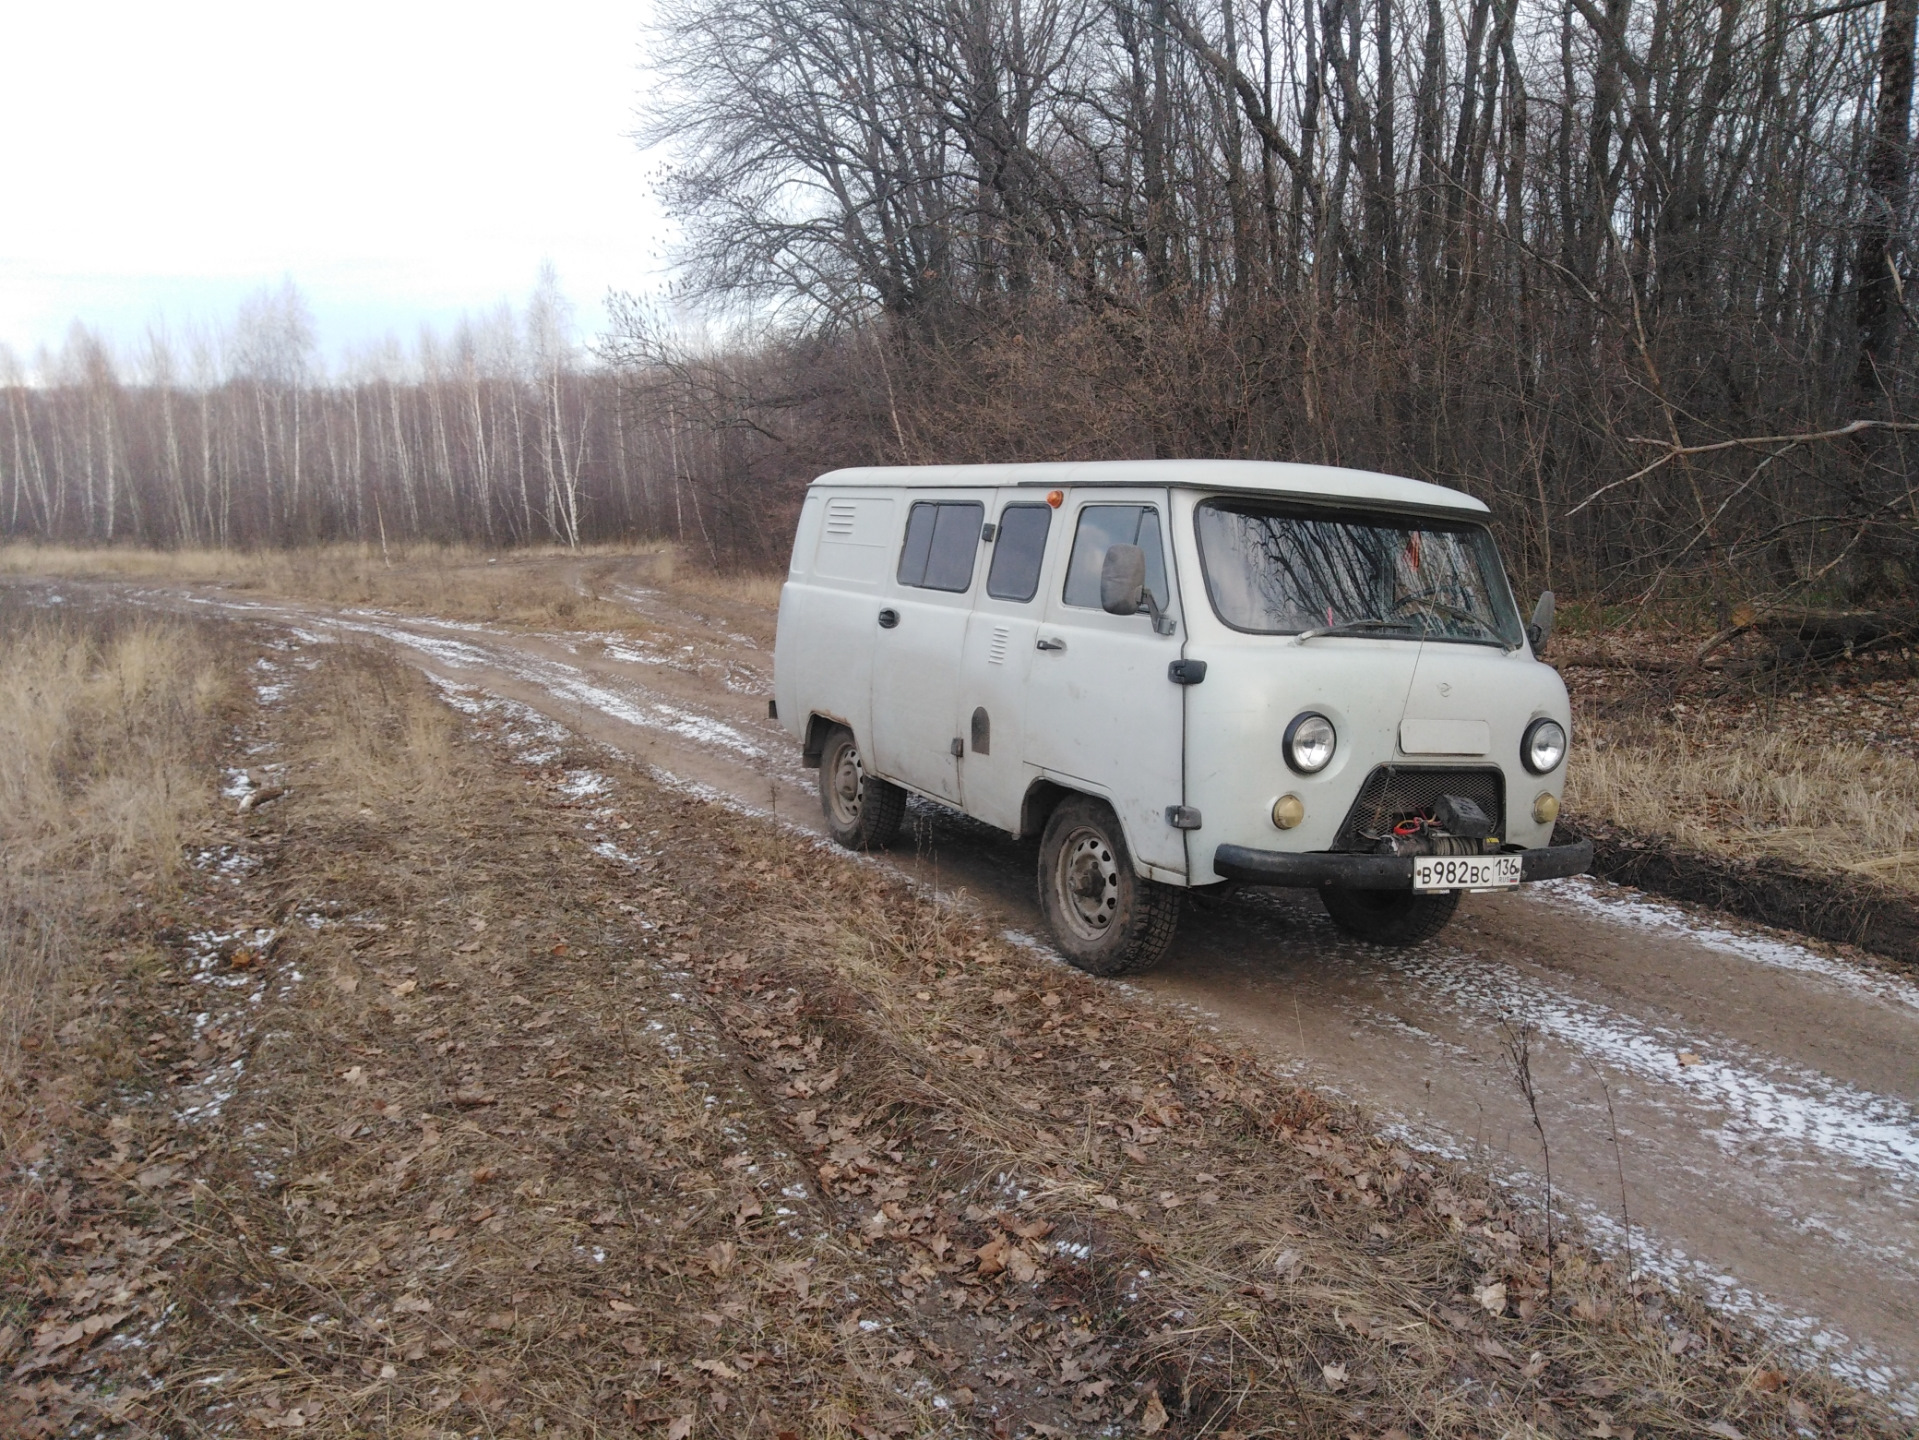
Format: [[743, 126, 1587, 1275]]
[[0, 0, 1919, 601]]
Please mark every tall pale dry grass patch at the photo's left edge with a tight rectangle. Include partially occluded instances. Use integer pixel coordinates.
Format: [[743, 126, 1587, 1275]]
[[0, 599, 236, 1087]]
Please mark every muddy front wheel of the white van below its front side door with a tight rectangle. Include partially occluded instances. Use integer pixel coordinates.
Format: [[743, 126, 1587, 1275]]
[[1040, 795, 1180, 975]]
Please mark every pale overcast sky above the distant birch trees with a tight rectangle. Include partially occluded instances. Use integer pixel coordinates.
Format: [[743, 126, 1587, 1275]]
[[0, 0, 666, 372]]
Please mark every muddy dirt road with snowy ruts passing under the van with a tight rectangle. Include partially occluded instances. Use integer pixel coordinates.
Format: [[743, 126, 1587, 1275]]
[[78, 584, 1919, 1413]]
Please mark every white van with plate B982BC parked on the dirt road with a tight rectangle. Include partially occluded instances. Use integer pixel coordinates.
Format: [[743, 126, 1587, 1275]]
[[773, 461, 1593, 975]]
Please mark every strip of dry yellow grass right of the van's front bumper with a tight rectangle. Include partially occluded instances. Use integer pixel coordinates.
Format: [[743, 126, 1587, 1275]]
[[1566, 726, 1919, 889]]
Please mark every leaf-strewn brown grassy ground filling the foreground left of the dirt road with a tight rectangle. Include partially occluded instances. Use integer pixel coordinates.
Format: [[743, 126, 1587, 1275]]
[[0, 595, 1894, 1438]]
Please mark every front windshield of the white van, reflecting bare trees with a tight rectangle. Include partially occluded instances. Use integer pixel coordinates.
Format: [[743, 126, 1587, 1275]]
[[1194, 497, 1522, 647]]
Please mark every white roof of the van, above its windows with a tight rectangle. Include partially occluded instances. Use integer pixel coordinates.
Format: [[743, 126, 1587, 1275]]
[[814, 461, 1489, 515]]
